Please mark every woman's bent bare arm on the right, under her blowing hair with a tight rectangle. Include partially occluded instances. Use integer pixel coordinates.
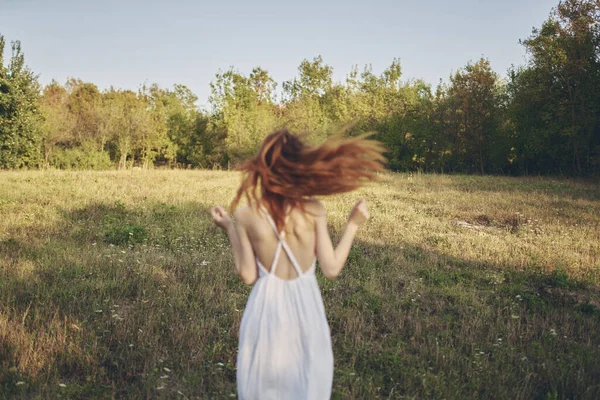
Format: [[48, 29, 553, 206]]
[[315, 200, 369, 279]]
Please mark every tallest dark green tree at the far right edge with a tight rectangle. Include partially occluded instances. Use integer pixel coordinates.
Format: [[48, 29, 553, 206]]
[[511, 0, 600, 174]]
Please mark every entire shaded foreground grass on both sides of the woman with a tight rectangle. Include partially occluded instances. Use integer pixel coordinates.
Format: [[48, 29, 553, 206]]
[[0, 202, 600, 399]]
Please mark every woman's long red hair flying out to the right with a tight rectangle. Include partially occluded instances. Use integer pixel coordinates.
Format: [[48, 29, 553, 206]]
[[231, 130, 386, 229]]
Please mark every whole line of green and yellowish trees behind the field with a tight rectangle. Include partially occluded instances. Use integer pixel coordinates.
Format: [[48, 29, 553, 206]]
[[0, 0, 600, 175]]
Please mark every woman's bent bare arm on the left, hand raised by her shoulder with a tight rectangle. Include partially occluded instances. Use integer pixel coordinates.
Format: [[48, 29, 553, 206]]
[[211, 206, 258, 285]]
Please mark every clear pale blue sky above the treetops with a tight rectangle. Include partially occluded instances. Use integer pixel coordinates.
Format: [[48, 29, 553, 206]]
[[0, 0, 558, 105]]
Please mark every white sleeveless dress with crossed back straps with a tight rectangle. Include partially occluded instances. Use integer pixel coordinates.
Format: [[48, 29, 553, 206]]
[[237, 212, 333, 400]]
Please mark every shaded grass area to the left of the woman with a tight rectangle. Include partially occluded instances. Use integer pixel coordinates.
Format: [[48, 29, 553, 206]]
[[0, 202, 247, 398]]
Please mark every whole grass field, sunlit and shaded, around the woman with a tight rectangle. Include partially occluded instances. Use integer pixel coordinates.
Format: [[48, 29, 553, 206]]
[[0, 171, 600, 399]]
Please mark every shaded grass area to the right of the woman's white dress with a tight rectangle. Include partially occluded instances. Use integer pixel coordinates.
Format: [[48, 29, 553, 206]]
[[322, 239, 600, 399]]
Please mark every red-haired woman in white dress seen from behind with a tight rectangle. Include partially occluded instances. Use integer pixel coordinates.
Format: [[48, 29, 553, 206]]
[[211, 131, 385, 400]]
